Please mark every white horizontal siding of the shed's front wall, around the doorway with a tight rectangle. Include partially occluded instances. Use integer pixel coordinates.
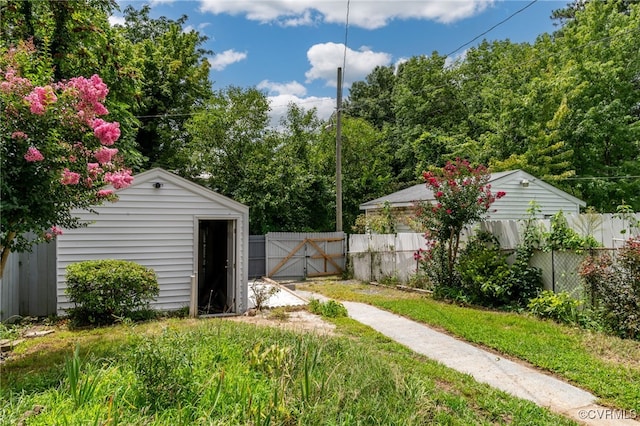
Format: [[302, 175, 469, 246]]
[[57, 181, 248, 311]]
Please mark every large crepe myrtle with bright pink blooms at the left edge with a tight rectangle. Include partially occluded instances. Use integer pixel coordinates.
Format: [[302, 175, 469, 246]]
[[0, 46, 133, 277]]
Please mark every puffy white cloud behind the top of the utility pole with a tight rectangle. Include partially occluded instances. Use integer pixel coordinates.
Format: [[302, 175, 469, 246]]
[[305, 43, 391, 87]]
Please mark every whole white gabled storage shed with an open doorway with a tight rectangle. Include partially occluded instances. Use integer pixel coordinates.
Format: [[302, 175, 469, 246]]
[[56, 168, 249, 315]]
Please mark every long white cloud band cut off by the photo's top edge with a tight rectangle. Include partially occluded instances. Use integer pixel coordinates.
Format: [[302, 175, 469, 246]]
[[198, 0, 496, 29]]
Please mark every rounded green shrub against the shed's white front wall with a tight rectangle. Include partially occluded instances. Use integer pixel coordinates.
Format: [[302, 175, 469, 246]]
[[65, 259, 159, 325]]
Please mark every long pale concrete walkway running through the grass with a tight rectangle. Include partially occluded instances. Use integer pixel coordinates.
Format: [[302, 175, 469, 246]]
[[296, 291, 640, 426]]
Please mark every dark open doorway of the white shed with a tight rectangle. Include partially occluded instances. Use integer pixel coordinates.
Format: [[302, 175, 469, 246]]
[[198, 220, 236, 315]]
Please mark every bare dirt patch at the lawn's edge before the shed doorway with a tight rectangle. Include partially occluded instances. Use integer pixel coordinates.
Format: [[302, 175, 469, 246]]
[[227, 310, 336, 336]]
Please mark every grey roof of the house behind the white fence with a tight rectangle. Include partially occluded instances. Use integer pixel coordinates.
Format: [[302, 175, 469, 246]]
[[360, 170, 586, 210]]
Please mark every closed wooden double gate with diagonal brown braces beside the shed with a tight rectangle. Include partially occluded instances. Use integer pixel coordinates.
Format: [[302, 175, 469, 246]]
[[266, 232, 346, 279]]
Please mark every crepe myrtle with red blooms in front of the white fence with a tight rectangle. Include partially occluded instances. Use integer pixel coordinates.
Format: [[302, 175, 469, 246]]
[[415, 158, 505, 287]]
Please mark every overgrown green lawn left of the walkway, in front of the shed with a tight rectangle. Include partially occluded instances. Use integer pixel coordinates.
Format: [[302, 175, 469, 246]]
[[0, 312, 574, 425]]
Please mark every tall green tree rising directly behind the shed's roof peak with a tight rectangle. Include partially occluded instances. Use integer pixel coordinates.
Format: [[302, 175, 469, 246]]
[[116, 5, 213, 172]]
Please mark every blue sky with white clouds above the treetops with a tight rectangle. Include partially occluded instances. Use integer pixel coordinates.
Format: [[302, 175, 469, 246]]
[[110, 0, 569, 120]]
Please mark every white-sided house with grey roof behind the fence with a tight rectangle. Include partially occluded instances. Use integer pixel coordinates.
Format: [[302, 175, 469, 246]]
[[360, 170, 586, 232]]
